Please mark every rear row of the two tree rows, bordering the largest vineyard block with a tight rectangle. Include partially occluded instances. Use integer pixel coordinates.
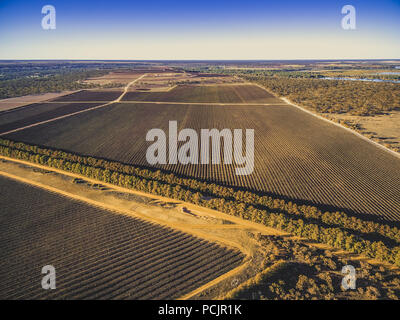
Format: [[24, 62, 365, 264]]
[[0, 139, 400, 243]]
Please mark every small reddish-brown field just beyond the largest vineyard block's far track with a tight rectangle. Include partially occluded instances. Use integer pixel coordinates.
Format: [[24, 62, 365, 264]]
[[122, 85, 279, 103]]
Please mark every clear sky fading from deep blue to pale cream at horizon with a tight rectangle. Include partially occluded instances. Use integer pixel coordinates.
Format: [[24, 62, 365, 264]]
[[0, 0, 400, 60]]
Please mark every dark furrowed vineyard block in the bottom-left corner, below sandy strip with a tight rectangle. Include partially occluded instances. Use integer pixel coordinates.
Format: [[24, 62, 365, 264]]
[[0, 176, 243, 299]]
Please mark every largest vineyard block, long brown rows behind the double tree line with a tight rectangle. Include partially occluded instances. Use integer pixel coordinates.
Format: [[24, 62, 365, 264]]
[[5, 103, 400, 220]]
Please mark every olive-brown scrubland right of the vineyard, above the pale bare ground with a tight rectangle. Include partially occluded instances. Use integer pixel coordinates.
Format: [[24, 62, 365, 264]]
[[245, 76, 400, 115]]
